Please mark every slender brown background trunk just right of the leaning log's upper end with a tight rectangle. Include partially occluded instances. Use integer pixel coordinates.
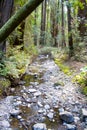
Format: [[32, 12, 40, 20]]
[[40, 0, 46, 45]]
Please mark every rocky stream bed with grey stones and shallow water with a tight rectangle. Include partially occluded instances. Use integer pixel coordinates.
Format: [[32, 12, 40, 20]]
[[0, 55, 87, 130]]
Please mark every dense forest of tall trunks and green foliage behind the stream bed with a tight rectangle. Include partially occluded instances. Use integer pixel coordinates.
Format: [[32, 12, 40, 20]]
[[0, 0, 87, 93]]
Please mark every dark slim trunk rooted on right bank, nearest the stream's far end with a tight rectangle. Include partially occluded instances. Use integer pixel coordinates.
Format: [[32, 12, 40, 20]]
[[67, 4, 74, 57]]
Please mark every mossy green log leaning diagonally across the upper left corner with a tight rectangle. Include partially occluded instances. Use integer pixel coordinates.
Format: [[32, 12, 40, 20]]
[[0, 0, 43, 42]]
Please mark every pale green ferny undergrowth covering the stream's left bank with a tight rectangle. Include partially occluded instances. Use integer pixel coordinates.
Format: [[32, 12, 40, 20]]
[[0, 45, 37, 78]]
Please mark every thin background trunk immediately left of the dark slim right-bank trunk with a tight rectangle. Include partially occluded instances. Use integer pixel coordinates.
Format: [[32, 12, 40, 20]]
[[61, 0, 65, 47]]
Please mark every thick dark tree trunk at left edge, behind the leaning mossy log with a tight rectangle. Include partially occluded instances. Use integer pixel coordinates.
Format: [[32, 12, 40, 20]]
[[0, 0, 14, 53]]
